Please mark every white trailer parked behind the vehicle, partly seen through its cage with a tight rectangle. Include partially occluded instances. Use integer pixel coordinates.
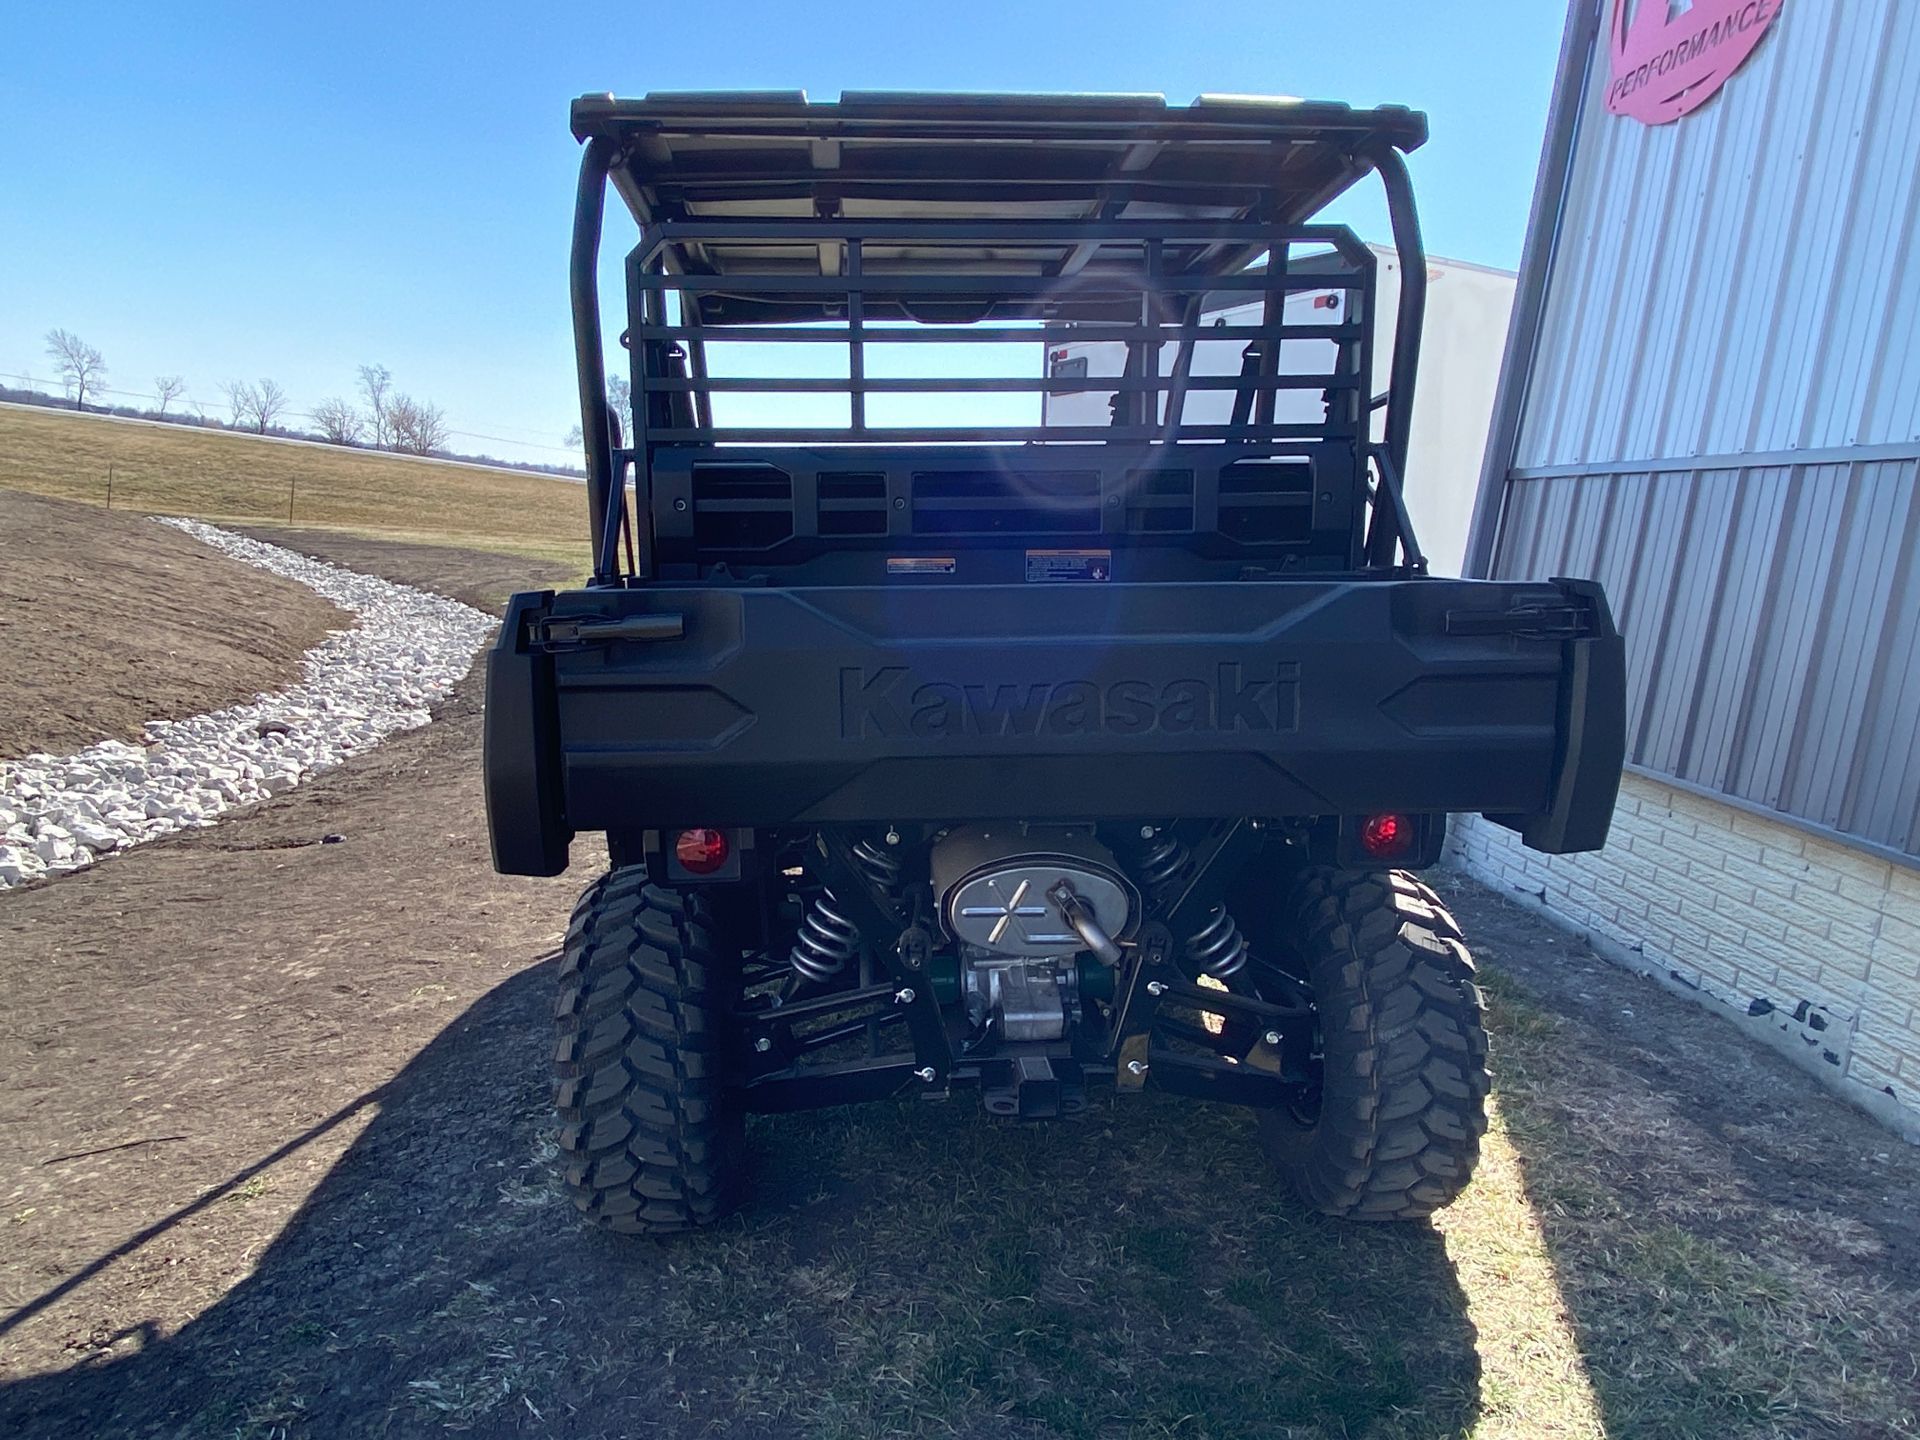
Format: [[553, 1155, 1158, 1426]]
[[1041, 246, 1513, 574]]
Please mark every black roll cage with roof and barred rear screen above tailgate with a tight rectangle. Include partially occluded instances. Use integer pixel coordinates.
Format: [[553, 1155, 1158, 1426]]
[[570, 94, 1427, 588]]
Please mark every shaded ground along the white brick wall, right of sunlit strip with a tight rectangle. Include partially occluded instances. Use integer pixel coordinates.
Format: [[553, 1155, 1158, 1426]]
[[1442, 876, 1920, 1440]]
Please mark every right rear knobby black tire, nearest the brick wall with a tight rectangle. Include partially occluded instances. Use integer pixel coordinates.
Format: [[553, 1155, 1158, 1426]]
[[1260, 870, 1488, 1221]]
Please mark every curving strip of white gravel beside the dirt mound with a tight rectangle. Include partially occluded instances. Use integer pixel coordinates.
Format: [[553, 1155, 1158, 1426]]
[[0, 520, 497, 889]]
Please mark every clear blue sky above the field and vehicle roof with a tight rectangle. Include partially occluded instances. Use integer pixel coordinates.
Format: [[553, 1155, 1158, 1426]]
[[0, 0, 1563, 461]]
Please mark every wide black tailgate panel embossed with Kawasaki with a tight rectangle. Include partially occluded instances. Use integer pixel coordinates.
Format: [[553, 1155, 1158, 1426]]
[[486, 580, 1624, 874]]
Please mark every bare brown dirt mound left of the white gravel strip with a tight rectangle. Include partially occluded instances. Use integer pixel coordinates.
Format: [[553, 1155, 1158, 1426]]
[[0, 495, 353, 758]]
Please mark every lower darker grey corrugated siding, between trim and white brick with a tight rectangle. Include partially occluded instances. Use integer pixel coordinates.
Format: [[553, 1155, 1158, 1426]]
[[1494, 461, 1920, 856]]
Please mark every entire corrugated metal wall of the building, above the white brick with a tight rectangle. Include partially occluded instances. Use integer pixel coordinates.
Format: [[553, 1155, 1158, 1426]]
[[1488, 0, 1920, 856]]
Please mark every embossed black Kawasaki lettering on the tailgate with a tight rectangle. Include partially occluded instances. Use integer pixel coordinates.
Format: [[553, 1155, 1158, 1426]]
[[841, 662, 1300, 739]]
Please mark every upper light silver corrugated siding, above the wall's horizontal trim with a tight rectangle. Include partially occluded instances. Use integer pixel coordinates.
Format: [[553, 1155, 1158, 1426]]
[[1515, 0, 1920, 470]]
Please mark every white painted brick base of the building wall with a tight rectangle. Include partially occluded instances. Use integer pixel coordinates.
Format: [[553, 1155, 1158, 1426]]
[[1448, 776, 1920, 1142]]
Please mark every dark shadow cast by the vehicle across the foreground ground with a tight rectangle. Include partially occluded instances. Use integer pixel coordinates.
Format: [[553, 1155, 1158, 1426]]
[[0, 964, 1478, 1436]]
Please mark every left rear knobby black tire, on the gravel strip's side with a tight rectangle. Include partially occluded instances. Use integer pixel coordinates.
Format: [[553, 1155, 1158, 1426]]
[[553, 870, 745, 1235]]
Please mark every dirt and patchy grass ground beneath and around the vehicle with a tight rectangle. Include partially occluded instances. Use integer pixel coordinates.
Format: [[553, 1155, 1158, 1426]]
[[0, 536, 1920, 1440]]
